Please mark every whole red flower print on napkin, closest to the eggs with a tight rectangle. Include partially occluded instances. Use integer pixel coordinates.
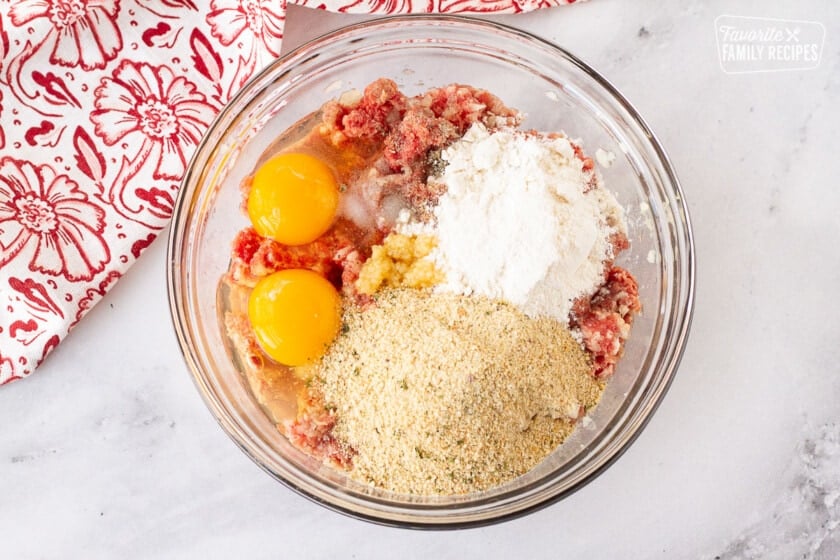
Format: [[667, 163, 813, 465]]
[[91, 60, 216, 181]]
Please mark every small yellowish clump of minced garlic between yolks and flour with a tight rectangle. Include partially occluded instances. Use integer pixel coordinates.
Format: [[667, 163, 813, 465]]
[[356, 233, 443, 295]]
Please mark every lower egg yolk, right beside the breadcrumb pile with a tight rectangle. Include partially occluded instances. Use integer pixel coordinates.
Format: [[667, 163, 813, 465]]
[[248, 269, 341, 366]]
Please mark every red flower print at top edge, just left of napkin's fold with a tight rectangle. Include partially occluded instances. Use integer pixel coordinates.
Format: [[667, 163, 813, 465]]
[[207, 0, 285, 56]]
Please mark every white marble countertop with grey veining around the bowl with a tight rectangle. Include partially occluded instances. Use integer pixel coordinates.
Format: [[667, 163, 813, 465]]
[[0, 0, 840, 560]]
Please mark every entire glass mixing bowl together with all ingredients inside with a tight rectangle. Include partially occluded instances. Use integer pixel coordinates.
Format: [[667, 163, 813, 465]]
[[168, 16, 694, 528]]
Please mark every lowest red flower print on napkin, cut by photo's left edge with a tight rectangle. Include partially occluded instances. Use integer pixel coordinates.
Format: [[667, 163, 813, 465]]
[[0, 157, 110, 281]]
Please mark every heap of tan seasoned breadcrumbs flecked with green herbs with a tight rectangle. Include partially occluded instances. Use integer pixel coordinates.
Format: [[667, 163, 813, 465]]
[[313, 289, 604, 495]]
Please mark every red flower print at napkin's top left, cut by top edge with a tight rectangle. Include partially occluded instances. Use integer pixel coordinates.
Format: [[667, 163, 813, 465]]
[[9, 0, 122, 70]]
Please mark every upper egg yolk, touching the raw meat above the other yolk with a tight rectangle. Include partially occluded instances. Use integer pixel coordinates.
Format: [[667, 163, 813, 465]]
[[248, 153, 338, 245]]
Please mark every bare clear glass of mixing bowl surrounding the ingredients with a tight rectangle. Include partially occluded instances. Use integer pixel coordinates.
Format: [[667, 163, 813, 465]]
[[168, 16, 694, 528]]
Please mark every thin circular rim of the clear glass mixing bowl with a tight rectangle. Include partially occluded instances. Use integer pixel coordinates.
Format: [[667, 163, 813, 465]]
[[166, 14, 696, 529]]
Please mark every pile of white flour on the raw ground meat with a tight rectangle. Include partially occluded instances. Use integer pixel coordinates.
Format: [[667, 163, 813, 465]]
[[418, 124, 625, 323]]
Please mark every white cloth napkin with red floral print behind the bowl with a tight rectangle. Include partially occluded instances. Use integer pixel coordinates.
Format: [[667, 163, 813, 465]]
[[0, 0, 574, 385]]
